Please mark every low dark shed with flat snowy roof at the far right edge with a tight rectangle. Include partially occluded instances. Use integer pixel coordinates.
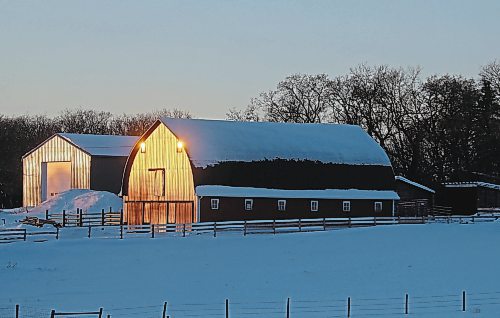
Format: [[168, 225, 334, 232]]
[[436, 181, 500, 215]]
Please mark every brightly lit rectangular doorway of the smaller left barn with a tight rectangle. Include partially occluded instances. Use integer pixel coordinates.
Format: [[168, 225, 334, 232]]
[[41, 161, 71, 201]]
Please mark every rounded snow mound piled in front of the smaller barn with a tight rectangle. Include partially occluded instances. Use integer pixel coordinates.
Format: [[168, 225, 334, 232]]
[[30, 189, 123, 213]]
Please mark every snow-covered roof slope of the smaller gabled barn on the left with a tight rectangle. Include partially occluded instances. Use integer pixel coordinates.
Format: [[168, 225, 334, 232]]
[[57, 133, 139, 157]]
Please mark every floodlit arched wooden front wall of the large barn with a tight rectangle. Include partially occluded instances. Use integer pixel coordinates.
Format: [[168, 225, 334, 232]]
[[124, 125, 196, 224]]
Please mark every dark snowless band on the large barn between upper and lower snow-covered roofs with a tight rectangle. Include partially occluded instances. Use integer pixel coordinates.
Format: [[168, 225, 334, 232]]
[[193, 159, 395, 190]]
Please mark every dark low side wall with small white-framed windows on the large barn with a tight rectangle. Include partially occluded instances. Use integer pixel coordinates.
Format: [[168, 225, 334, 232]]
[[199, 197, 393, 222]]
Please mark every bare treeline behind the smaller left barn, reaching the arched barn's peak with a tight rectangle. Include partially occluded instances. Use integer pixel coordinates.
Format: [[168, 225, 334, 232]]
[[0, 109, 191, 208]]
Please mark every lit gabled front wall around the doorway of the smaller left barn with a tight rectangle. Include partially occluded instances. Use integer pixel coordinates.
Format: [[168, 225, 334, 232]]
[[23, 136, 91, 206]]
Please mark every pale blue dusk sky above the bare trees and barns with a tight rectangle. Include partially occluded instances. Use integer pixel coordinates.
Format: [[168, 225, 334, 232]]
[[0, 0, 500, 118]]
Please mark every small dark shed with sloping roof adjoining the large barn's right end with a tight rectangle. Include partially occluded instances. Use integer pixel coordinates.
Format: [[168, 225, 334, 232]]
[[396, 176, 436, 216]]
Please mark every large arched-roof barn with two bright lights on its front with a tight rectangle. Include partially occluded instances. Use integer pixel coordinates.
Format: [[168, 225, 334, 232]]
[[122, 118, 399, 224]]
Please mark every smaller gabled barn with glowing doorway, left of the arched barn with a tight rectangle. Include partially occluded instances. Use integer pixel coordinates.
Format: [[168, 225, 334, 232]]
[[22, 133, 139, 206]]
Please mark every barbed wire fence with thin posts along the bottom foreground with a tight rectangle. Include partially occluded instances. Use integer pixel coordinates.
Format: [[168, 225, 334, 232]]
[[0, 291, 500, 318]]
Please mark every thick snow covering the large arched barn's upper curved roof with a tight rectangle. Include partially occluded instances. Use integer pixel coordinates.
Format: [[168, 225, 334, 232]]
[[161, 118, 391, 167]]
